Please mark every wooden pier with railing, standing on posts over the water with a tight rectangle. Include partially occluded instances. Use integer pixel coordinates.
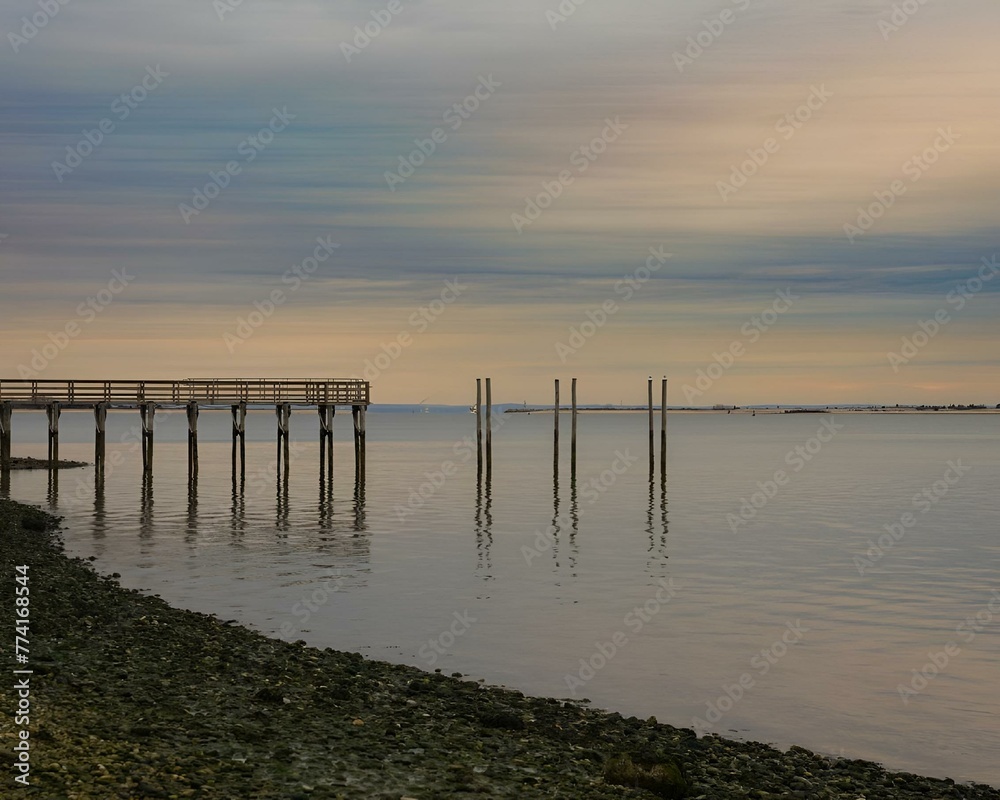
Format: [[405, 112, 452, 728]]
[[0, 378, 371, 481]]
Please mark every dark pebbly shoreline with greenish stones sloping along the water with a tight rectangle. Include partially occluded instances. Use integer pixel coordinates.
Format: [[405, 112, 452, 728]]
[[0, 500, 1000, 800]]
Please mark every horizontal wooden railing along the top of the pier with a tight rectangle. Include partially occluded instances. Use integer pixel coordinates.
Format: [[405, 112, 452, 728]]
[[0, 378, 369, 406]]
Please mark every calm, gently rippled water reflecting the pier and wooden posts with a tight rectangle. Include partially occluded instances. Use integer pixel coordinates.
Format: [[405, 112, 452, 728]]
[[4, 411, 1000, 785]]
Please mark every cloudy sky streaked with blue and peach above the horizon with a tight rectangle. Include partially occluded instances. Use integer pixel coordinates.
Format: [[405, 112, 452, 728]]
[[0, 0, 1000, 405]]
